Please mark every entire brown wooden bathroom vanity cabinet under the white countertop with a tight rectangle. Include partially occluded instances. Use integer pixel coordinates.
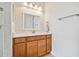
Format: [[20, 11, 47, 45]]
[[13, 34, 52, 57]]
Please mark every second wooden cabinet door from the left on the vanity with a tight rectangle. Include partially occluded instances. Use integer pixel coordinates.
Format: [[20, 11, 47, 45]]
[[27, 41, 38, 57]]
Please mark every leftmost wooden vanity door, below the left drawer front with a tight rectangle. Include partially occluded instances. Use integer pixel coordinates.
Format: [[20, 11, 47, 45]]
[[13, 43, 26, 57]]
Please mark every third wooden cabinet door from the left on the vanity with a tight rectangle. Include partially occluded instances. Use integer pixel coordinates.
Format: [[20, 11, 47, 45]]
[[38, 39, 46, 56]]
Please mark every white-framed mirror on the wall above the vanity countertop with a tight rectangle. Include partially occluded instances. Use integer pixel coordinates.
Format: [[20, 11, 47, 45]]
[[23, 13, 40, 30]]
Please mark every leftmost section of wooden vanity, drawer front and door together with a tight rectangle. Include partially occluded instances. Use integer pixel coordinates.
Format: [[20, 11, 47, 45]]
[[13, 38, 26, 57]]
